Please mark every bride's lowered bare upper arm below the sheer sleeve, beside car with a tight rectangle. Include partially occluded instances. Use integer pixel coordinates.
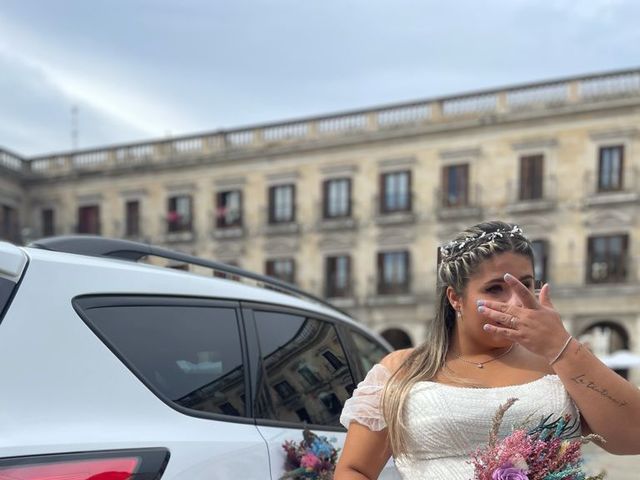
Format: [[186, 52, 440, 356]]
[[333, 422, 391, 480]]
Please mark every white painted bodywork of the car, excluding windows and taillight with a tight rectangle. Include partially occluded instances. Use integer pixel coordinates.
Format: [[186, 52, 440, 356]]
[[0, 248, 399, 480]]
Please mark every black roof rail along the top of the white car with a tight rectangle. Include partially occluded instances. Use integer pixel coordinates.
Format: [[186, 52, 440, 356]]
[[27, 235, 350, 317]]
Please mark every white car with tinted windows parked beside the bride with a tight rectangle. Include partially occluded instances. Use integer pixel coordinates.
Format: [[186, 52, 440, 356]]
[[0, 236, 397, 480]]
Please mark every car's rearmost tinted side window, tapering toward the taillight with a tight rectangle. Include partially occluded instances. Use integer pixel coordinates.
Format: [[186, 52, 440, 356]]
[[78, 305, 246, 417]]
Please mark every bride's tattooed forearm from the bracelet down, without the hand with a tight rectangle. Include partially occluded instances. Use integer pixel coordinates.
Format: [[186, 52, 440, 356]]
[[553, 339, 640, 455]]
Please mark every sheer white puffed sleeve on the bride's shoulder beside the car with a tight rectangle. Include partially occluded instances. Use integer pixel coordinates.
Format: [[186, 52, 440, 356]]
[[340, 363, 391, 432]]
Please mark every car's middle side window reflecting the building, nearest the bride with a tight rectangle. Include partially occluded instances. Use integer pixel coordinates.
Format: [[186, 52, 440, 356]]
[[254, 310, 354, 426]]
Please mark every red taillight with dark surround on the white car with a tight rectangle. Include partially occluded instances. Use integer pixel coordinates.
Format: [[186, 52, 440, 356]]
[[0, 448, 169, 480]]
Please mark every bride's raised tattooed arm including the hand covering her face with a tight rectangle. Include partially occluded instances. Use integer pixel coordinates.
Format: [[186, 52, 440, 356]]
[[478, 274, 640, 455]]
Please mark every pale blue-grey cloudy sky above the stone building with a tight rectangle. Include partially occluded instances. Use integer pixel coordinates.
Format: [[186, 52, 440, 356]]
[[0, 0, 640, 156]]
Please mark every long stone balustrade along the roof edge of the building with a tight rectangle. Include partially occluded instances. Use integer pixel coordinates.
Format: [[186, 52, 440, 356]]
[[12, 69, 640, 175]]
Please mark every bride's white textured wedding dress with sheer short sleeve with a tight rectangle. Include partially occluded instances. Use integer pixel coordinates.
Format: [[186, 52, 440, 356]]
[[340, 364, 579, 480]]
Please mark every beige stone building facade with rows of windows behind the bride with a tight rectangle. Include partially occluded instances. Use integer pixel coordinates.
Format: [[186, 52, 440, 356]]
[[0, 70, 640, 382]]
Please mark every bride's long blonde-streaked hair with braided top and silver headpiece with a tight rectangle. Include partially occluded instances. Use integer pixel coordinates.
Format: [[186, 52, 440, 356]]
[[382, 221, 533, 457]]
